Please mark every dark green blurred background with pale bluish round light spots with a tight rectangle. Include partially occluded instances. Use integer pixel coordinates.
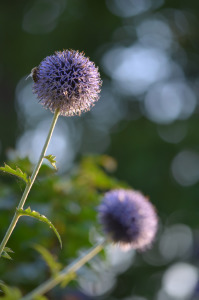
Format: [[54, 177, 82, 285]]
[[0, 0, 199, 300]]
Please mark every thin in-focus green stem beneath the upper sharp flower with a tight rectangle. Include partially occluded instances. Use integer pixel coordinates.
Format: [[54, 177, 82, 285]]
[[0, 109, 59, 256]]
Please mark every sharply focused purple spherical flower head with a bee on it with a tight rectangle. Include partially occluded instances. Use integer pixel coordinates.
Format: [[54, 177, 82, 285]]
[[31, 50, 102, 116]]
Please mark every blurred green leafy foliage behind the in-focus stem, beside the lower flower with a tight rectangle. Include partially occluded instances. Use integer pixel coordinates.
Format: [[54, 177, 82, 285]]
[[0, 155, 124, 296]]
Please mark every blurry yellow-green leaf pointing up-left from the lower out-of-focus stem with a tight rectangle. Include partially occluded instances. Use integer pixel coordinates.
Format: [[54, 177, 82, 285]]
[[34, 245, 62, 275]]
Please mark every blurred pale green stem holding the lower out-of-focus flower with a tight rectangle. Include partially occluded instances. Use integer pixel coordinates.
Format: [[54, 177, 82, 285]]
[[21, 242, 104, 300]]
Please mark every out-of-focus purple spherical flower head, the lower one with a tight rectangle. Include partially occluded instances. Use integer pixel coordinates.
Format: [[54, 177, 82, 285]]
[[98, 189, 158, 250]]
